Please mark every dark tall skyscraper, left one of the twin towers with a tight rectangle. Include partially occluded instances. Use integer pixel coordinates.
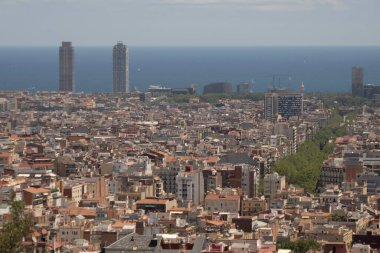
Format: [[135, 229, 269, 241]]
[[59, 41, 75, 91]]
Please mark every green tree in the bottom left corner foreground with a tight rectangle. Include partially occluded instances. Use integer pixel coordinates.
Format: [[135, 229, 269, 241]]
[[0, 194, 32, 253]]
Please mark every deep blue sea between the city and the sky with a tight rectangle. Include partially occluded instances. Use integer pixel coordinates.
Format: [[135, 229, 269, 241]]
[[0, 47, 380, 92]]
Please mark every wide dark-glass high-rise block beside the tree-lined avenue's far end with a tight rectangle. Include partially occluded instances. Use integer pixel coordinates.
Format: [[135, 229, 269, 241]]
[[264, 90, 303, 120]]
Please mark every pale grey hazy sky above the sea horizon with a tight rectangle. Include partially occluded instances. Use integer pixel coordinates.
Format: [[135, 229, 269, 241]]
[[0, 0, 380, 46]]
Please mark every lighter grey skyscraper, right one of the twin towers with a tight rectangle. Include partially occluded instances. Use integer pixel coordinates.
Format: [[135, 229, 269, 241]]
[[113, 42, 129, 93]]
